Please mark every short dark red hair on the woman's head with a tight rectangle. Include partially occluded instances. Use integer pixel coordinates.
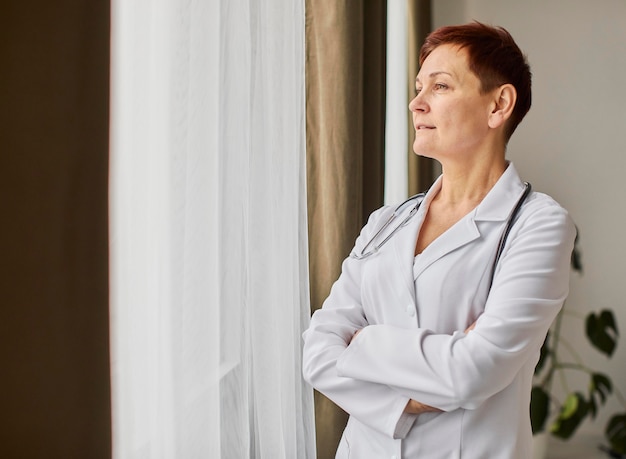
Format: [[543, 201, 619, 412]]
[[419, 21, 532, 140]]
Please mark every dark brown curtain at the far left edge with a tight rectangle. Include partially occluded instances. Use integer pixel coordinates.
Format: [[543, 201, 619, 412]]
[[0, 0, 111, 458]]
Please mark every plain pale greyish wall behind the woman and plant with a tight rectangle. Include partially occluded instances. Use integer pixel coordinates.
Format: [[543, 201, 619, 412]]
[[433, 0, 626, 431]]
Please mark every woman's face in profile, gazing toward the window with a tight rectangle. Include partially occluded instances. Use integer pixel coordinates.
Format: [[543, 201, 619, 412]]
[[409, 45, 495, 161]]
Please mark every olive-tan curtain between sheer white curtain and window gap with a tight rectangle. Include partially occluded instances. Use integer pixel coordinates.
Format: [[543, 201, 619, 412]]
[[306, 0, 386, 458]]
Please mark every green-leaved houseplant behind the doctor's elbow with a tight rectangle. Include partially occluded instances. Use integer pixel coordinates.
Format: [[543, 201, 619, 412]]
[[530, 237, 626, 457]]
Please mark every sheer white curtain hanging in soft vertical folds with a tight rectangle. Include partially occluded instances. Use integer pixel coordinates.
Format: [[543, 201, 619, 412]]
[[110, 0, 315, 459]]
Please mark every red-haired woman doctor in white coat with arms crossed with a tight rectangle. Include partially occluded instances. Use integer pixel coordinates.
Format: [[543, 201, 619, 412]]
[[303, 23, 575, 459]]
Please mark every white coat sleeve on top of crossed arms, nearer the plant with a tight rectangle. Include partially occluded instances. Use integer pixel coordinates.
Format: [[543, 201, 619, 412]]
[[337, 201, 576, 411]]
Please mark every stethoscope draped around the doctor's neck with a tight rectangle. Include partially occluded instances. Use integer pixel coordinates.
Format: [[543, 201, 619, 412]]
[[350, 182, 532, 282]]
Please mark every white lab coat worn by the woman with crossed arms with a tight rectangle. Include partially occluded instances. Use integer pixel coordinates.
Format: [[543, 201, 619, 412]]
[[303, 164, 575, 459]]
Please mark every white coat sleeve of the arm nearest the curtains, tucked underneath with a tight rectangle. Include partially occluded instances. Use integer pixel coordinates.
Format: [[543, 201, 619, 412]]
[[303, 208, 416, 438]]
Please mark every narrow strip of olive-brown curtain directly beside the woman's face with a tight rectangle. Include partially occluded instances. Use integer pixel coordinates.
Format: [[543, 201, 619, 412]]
[[407, 0, 436, 196]]
